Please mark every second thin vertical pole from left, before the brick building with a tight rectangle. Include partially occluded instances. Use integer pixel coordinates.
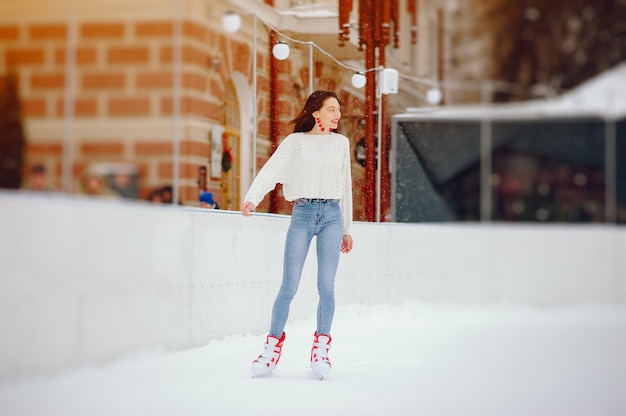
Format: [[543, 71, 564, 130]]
[[172, 0, 183, 204]]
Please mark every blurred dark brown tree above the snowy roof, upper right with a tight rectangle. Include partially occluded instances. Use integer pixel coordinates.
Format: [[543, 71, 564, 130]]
[[475, 0, 626, 101]]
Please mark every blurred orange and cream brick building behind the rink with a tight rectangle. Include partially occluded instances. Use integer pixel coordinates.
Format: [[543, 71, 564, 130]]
[[0, 0, 468, 219]]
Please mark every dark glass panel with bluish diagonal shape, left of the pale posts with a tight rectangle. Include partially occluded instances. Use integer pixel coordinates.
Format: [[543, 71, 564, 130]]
[[394, 120, 480, 222]]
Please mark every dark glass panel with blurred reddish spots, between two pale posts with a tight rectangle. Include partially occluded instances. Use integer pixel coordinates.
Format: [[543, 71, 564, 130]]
[[492, 119, 605, 222]]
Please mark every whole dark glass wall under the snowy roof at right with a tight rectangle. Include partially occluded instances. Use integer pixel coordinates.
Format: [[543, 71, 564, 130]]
[[392, 116, 626, 224]]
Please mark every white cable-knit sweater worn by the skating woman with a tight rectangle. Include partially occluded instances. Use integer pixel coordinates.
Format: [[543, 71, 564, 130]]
[[244, 133, 352, 235]]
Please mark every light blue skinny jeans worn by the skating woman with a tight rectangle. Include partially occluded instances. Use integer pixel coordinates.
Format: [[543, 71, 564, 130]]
[[270, 198, 342, 338]]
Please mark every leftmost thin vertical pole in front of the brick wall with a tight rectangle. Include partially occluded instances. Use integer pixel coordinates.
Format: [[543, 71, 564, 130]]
[[61, 0, 77, 193]]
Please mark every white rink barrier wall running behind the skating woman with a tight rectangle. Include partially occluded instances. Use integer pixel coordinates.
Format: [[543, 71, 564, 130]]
[[0, 192, 626, 381]]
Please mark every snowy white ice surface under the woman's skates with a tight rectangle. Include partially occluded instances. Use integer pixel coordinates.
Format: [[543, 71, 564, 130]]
[[0, 302, 626, 416]]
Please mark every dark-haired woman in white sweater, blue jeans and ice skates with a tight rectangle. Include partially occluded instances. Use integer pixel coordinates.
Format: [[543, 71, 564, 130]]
[[241, 90, 352, 379]]
